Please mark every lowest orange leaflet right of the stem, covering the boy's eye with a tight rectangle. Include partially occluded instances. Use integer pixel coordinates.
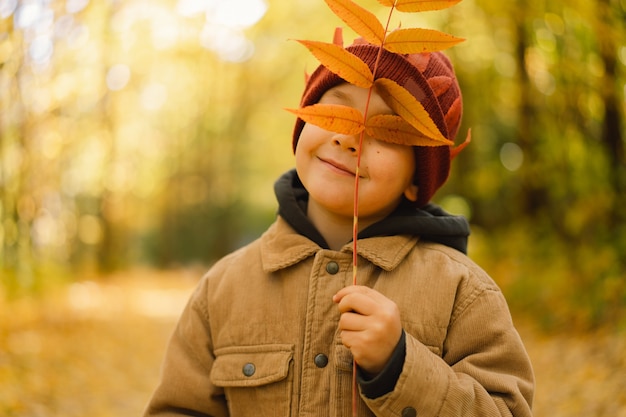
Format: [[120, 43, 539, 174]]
[[365, 114, 446, 146]]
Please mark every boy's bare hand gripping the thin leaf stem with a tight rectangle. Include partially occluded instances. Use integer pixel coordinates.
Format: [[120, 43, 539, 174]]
[[333, 285, 402, 376]]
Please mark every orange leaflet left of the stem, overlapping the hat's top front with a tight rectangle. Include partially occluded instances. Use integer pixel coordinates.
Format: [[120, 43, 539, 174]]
[[298, 40, 374, 88]]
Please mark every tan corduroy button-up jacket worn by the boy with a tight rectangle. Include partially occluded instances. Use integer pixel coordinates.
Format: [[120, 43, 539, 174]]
[[145, 217, 534, 417]]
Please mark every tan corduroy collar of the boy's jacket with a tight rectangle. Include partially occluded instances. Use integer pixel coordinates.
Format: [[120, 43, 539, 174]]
[[261, 216, 418, 272]]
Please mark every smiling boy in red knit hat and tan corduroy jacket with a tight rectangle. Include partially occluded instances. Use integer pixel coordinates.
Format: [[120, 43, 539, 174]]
[[146, 43, 534, 417]]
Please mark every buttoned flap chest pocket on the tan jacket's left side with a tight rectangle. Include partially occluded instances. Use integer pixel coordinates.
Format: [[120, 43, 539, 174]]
[[210, 344, 293, 416]]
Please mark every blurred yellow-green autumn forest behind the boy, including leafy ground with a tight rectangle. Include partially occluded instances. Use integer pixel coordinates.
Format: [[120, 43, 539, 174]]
[[0, 0, 626, 417]]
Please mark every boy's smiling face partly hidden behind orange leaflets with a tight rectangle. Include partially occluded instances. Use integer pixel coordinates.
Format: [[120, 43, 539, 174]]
[[296, 83, 417, 222]]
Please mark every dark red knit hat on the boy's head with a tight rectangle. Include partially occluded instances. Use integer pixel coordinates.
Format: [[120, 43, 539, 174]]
[[293, 42, 463, 207]]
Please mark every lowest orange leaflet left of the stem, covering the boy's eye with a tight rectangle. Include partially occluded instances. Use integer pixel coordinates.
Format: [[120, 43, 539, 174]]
[[287, 104, 364, 135]]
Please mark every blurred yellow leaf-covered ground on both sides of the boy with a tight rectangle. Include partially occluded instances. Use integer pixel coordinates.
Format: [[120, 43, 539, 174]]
[[0, 271, 626, 417]]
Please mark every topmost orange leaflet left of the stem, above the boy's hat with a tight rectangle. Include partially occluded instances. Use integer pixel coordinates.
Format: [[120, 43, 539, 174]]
[[325, 0, 385, 45]]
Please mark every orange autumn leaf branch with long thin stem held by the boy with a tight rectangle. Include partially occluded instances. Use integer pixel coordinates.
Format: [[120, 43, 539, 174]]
[[288, 0, 460, 410]]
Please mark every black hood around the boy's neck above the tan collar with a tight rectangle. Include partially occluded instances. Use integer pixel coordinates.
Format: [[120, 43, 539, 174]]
[[274, 169, 470, 253]]
